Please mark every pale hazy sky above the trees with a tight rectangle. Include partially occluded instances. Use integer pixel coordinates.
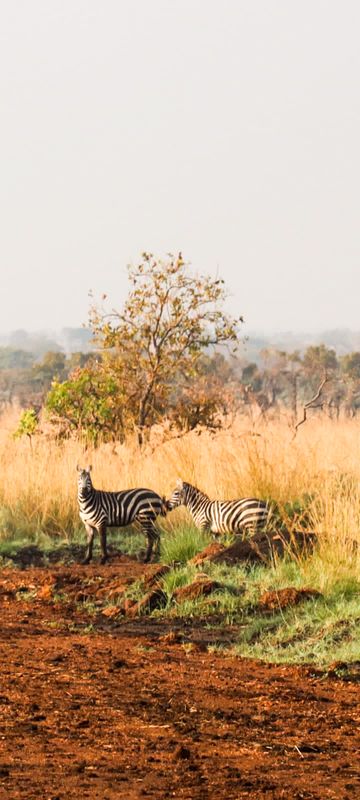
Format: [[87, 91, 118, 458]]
[[0, 0, 360, 331]]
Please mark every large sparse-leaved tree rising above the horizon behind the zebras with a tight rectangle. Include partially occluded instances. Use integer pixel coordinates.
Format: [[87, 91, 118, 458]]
[[48, 253, 243, 445]]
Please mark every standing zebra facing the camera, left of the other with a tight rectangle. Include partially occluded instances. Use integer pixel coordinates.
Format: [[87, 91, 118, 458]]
[[77, 466, 167, 564]]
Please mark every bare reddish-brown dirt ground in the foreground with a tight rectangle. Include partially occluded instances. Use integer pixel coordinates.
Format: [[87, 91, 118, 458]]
[[0, 557, 360, 800]]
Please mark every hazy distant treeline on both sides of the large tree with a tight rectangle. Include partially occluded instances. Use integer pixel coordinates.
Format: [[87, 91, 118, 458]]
[[0, 344, 360, 419]]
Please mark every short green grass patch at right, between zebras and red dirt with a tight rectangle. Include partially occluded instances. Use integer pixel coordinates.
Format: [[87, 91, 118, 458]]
[[153, 529, 360, 666]]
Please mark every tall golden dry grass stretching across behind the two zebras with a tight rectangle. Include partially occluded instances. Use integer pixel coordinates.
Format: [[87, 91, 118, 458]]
[[0, 411, 360, 580]]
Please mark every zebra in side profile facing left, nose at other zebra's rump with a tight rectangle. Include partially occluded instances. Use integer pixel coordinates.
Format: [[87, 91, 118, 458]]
[[166, 480, 270, 534]]
